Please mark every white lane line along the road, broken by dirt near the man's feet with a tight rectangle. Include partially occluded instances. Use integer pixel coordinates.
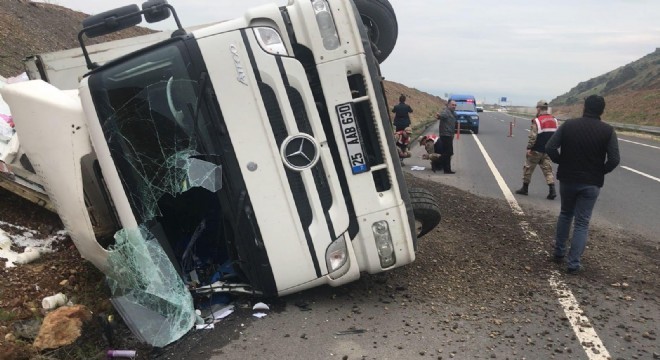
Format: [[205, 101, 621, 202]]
[[472, 134, 610, 360]]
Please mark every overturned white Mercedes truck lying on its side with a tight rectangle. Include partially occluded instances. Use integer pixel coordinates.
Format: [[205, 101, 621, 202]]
[[2, 0, 440, 346]]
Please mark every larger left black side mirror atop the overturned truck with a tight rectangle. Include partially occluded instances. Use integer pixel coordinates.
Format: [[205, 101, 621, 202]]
[[82, 4, 143, 38]]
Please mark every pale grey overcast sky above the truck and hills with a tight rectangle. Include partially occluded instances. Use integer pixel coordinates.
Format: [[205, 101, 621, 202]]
[[37, 0, 660, 105]]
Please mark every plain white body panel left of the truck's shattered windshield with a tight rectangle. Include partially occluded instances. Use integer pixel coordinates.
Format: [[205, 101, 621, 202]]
[[3, 80, 108, 271]]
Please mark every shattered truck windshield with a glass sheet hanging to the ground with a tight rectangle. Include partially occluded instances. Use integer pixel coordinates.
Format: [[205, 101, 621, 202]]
[[89, 41, 229, 346]]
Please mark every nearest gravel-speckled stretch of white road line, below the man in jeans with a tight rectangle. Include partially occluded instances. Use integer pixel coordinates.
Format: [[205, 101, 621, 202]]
[[549, 271, 611, 360]]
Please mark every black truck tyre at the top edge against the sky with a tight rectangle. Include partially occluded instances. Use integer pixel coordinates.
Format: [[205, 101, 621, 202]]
[[353, 0, 399, 64]]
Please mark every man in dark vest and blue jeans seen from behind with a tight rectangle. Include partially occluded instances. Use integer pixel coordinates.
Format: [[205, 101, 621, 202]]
[[545, 95, 620, 274]]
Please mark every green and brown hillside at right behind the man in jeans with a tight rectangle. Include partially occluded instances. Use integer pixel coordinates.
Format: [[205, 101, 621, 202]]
[[550, 48, 660, 126]]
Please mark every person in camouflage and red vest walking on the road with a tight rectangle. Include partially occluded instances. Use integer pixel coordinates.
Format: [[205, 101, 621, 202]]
[[516, 100, 558, 200]]
